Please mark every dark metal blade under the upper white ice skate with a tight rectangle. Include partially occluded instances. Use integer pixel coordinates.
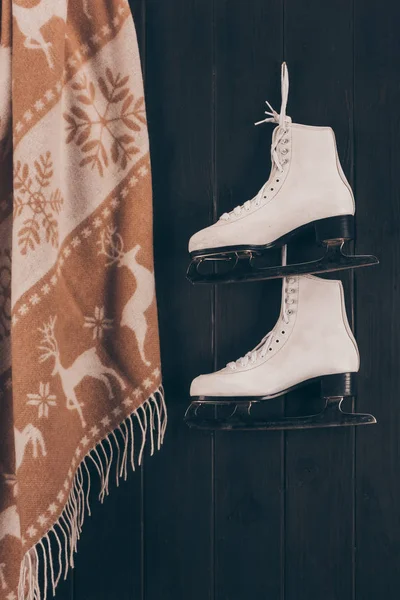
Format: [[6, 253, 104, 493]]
[[187, 240, 379, 284]]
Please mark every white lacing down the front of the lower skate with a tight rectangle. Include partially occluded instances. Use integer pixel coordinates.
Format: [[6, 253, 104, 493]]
[[226, 246, 295, 371]]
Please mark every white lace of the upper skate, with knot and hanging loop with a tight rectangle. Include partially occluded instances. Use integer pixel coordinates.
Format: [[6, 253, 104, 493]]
[[220, 63, 291, 221]]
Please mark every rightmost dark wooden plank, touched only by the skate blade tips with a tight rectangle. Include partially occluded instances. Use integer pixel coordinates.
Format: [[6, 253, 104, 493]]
[[355, 0, 400, 600]]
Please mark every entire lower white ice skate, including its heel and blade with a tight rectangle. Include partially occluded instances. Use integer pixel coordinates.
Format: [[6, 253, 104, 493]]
[[185, 275, 376, 430]]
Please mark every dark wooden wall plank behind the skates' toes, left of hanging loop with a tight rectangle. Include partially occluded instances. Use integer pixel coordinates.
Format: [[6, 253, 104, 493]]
[[215, 0, 283, 600]]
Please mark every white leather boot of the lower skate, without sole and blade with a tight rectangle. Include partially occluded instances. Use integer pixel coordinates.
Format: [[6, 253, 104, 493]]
[[190, 275, 360, 400]]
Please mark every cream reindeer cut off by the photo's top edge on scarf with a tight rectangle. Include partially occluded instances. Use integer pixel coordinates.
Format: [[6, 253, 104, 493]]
[[13, 0, 67, 69]]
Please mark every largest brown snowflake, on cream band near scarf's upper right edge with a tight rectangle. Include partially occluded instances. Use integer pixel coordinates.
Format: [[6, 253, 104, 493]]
[[64, 70, 146, 176]]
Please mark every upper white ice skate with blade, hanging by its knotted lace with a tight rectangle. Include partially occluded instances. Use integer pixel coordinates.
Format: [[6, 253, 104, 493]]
[[187, 63, 378, 283]]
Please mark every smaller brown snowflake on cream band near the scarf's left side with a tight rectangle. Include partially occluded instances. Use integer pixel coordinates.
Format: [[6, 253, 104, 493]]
[[14, 152, 64, 255]]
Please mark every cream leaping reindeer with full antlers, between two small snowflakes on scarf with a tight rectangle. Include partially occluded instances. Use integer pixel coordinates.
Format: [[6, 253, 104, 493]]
[[39, 317, 126, 427]]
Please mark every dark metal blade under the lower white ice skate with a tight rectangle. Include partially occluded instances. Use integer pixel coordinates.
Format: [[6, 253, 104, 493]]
[[185, 397, 376, 431]]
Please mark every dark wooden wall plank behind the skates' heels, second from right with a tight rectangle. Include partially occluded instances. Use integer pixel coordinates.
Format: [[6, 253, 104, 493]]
[[285, 0, 354, 600]]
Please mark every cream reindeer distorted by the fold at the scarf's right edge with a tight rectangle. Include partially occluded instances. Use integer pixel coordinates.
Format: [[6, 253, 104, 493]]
[[98, 227, 155, 366]]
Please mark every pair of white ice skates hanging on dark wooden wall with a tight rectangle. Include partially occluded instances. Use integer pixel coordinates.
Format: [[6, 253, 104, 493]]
[[186, 63, 378, 429]]
